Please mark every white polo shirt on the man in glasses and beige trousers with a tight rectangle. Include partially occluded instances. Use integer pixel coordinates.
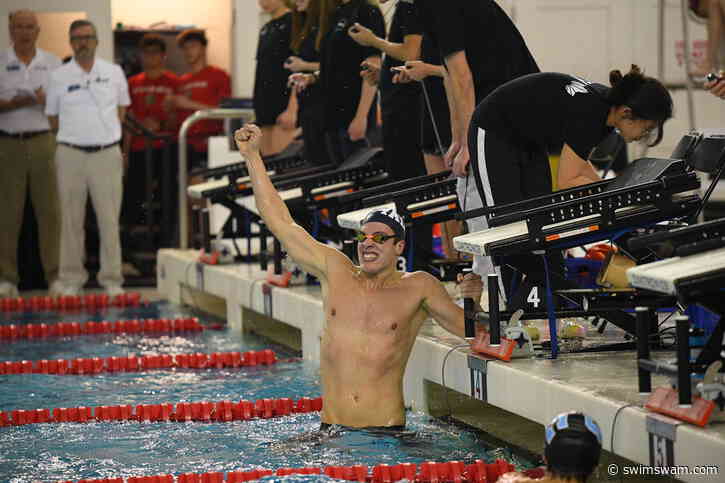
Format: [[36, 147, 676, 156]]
[[45, 57, 131, 146]]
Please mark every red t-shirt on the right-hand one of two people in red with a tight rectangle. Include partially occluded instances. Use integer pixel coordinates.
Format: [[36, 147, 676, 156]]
[[178, 65, 232, 151]]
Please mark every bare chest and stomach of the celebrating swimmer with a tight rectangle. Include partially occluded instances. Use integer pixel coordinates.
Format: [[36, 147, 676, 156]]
[[320, 270, 427, 427]]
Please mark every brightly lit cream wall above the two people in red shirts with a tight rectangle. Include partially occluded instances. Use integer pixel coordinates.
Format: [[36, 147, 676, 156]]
[[111, 0, 232, 73]]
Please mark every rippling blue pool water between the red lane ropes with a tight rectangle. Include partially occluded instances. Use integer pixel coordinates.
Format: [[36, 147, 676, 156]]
[[0, 302, 532, 483]]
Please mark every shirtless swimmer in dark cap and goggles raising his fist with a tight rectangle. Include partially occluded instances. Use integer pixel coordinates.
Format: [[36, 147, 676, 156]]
[[234, 124, 483, 429]]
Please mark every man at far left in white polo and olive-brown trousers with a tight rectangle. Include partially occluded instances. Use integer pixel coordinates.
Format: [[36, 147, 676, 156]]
[[0, 10, 60, 297]]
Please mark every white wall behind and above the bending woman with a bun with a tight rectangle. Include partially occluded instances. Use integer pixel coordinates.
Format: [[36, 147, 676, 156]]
[[512, 0, 725, 156]]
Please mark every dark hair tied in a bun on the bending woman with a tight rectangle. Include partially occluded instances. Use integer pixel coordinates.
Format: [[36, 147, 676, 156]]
[[607, 64, 672, 146]]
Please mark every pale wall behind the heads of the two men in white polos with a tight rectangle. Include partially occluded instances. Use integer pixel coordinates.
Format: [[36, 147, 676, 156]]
[[0, 0, 113, 60]]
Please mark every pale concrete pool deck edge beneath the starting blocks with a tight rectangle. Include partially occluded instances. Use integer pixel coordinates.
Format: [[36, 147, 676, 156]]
[[157, 249, 725, 481]]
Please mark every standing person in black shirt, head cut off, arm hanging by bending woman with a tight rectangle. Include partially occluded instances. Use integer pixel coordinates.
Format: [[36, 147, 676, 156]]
[[415, 0, 539, 282]]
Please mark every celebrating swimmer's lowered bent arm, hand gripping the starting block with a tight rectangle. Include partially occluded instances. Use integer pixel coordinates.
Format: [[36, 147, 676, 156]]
[[422, 272, 483, 337]]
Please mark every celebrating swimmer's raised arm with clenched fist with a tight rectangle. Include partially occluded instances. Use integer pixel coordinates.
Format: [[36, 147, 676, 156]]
[[234, 124, 337, 279]]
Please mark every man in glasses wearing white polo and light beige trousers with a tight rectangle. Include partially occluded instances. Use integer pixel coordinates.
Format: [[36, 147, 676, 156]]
[[45, 20, 131, 295]]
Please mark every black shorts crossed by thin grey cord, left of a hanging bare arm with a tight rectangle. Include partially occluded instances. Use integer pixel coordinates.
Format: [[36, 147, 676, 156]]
[[420, 77, 451, 156]]
